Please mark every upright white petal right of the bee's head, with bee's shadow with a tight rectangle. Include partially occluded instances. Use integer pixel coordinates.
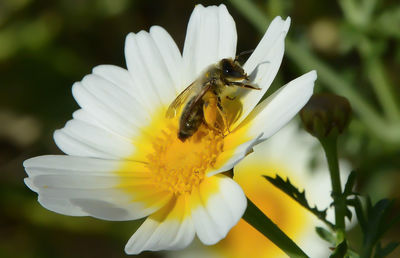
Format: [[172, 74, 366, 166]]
[[236, 16, 290, 127]]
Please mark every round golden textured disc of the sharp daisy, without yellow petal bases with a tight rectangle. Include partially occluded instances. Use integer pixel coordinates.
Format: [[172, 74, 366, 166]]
[[146, 123, 224, 195]]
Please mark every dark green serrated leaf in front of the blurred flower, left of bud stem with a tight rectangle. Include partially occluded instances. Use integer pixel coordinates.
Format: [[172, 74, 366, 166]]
[[263, 175, 334, 228]]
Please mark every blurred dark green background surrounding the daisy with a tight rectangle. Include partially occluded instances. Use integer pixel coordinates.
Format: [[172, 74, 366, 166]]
[[0, 0, 400, 257]]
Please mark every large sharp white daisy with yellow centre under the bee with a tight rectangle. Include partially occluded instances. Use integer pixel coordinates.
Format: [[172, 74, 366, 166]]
[[24, 5, 316, 254]]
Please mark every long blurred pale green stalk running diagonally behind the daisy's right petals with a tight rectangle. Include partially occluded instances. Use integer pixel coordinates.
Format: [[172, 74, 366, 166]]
[[230, 0, 400, 144]]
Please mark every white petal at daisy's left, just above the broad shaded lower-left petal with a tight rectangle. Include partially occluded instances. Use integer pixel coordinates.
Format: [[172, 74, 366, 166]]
[[54, 119, 134, 159]]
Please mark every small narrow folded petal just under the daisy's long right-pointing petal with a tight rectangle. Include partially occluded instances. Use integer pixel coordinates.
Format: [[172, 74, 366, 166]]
[[207, 133, 262, 177]]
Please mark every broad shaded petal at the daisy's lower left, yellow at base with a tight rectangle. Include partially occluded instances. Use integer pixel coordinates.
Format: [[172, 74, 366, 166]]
[[24, 156, 171, 220]]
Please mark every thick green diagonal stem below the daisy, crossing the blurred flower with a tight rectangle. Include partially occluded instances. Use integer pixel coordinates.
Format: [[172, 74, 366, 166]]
[[243, 199, 308, 257]]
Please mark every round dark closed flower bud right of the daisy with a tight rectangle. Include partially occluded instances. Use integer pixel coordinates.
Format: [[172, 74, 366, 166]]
[[300, 93, 351, 138]]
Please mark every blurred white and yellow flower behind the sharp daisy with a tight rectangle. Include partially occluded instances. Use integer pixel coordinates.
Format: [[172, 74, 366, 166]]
[[168, 121, 356, 258]]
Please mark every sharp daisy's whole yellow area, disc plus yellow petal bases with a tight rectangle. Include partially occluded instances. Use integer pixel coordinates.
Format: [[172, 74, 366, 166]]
[[116, 102, 250, 203]]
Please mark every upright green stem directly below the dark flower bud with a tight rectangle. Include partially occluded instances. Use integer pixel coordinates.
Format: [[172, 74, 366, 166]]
[[319, 136, 346, 234]]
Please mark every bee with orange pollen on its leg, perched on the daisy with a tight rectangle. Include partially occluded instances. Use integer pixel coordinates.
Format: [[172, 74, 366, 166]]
[[166, 58, 260, 142]]
